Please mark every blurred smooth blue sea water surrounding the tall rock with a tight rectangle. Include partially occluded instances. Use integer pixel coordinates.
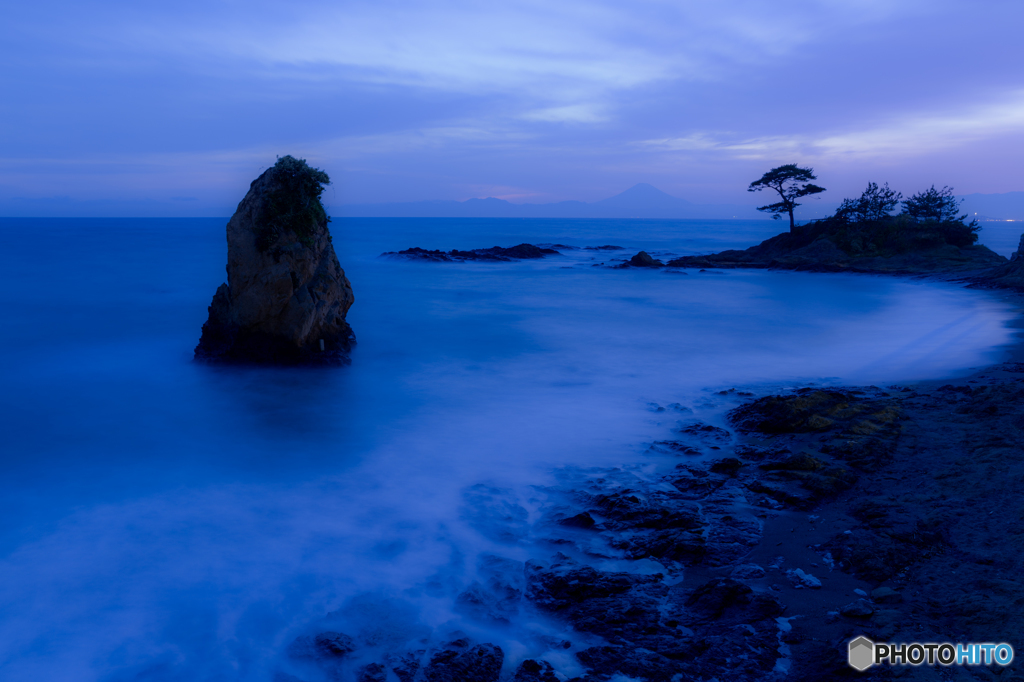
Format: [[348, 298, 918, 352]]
[[0, 219, 1016, 682]]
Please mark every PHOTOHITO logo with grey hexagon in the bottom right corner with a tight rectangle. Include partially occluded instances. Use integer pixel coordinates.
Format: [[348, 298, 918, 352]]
[[847, 637, 1014, 672]]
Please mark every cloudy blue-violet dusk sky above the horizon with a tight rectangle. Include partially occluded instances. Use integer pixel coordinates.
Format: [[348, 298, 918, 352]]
[[0, 0, 1024, 216]]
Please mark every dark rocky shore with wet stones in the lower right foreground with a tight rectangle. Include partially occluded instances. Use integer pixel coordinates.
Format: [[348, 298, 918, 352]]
[[270, 372, 1024, 682]]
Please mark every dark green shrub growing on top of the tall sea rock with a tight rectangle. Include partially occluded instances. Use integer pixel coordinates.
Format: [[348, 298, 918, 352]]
[[256, 156, 331, 251]]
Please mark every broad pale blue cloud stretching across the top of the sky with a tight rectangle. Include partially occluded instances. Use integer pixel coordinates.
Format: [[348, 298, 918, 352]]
[[22, 0, 937, 110]]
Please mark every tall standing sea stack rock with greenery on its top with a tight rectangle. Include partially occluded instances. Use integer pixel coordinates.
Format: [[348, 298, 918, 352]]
[[196, 157, 355, 365]]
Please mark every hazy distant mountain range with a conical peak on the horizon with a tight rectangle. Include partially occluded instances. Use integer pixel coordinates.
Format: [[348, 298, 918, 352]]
[[335, 182, 766, 219]]
